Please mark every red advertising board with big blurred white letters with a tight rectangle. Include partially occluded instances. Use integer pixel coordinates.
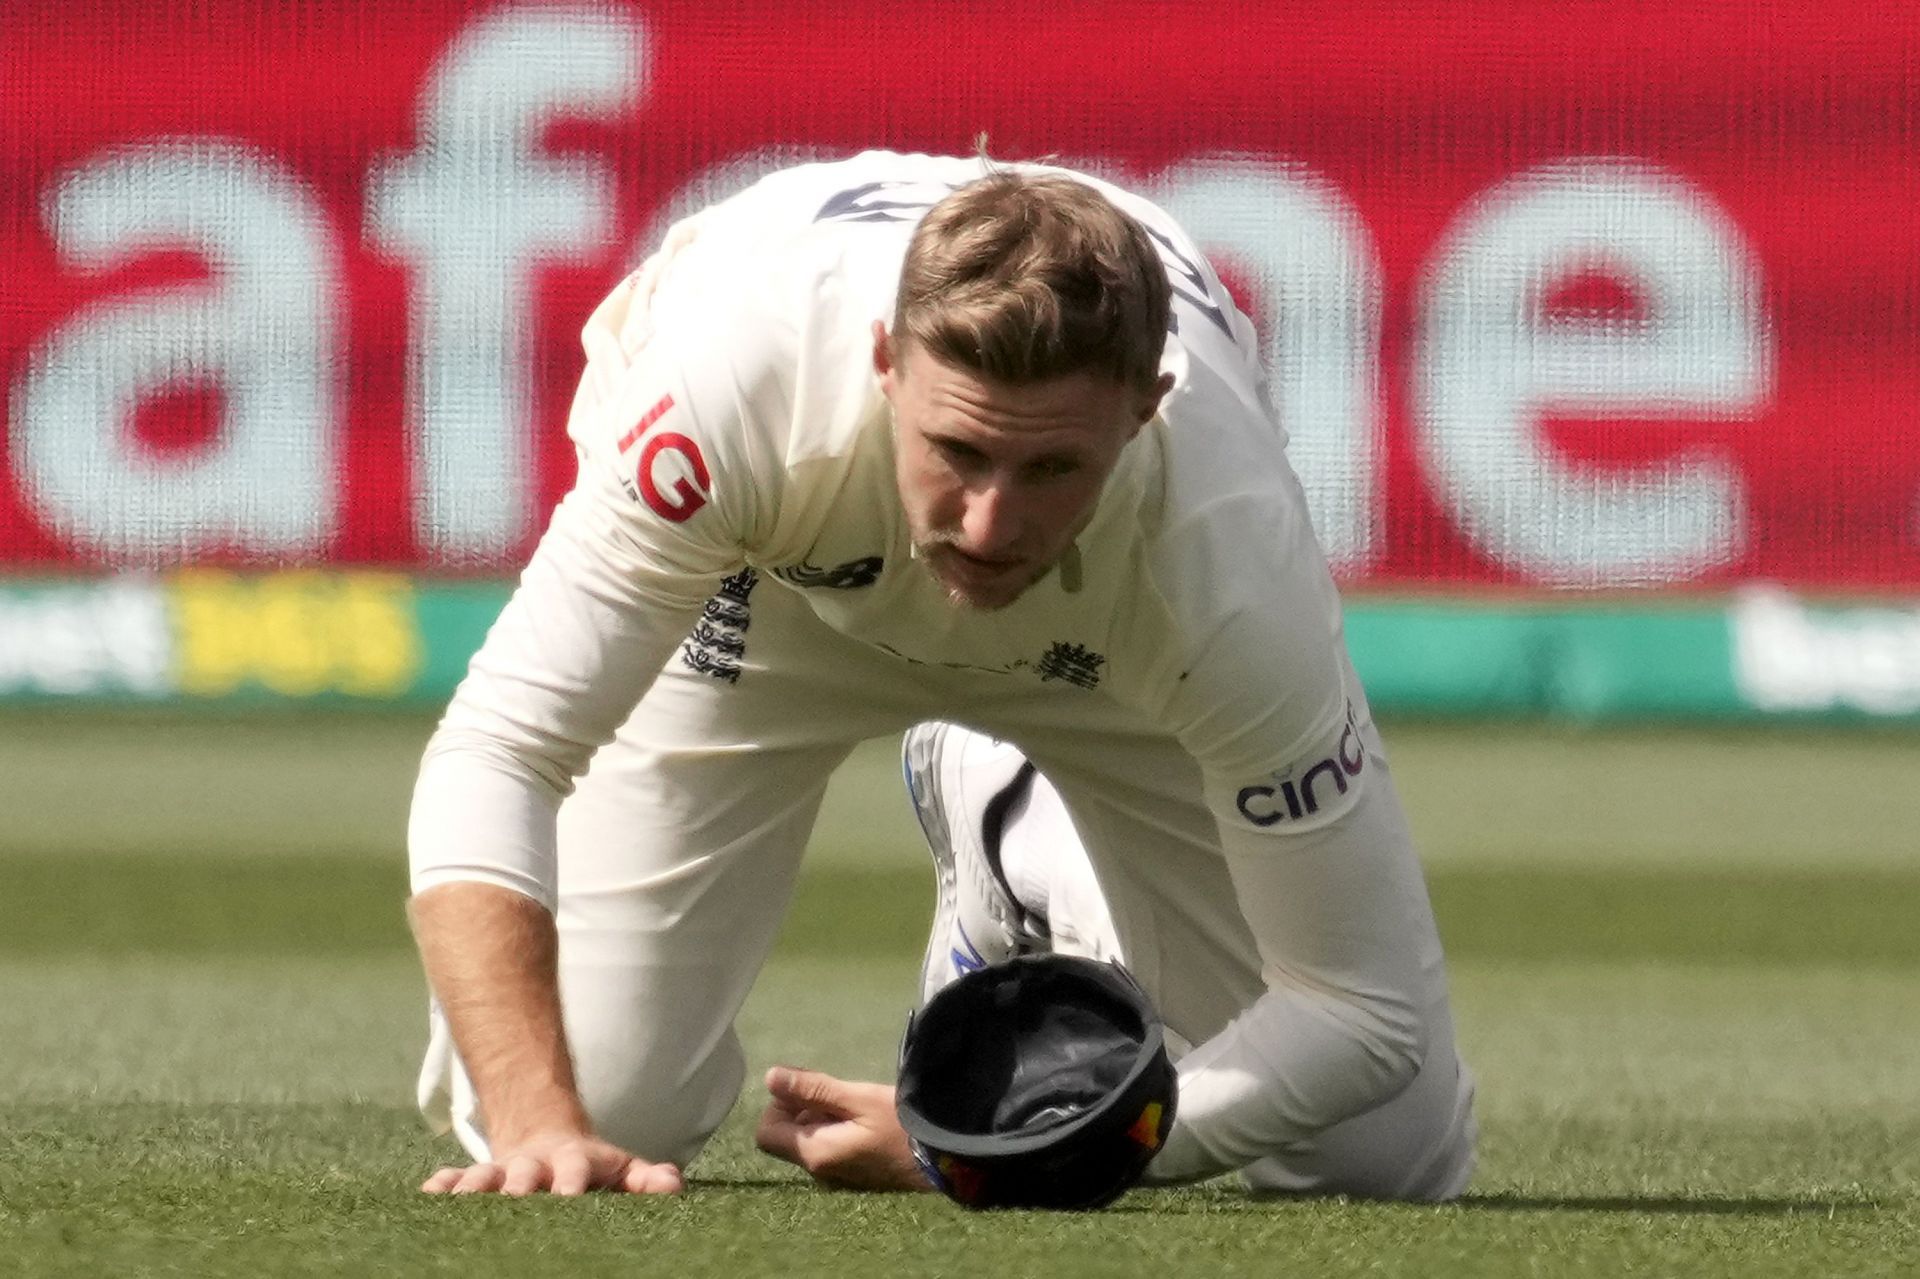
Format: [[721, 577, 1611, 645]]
[[0, 0, 1920, 591]]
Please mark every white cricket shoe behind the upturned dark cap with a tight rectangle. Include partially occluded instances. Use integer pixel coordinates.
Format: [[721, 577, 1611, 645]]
[[900, 720, 1050, 1002]]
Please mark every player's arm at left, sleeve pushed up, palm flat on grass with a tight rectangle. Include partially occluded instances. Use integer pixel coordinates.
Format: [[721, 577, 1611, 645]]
[[407, 349, 743, 1193]]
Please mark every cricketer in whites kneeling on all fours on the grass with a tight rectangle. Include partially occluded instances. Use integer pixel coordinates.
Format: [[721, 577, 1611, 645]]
[[409, 152, 1475, 1200]]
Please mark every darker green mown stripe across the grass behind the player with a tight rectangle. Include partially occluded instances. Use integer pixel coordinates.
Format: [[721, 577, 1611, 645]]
[[0, 853, 1920, 968]]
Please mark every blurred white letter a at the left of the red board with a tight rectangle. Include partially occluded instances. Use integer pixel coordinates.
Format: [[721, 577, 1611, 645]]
[[12, 138, 344, 563]]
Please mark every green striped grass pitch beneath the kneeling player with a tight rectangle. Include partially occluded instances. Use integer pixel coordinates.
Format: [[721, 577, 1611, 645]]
[[0, 712, 1920, 1279]]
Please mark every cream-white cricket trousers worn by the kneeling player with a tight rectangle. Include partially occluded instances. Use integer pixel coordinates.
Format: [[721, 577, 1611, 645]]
[[419, 580, 1473, 1198]]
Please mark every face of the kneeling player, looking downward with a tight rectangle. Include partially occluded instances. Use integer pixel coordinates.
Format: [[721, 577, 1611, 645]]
[[874, 323, 1173, 609]]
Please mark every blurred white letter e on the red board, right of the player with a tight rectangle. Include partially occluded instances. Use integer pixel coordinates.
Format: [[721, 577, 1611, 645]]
[[1411, 161, 1774, 586]]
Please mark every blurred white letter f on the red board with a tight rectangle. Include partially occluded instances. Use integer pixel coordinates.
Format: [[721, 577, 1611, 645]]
[[367, 6, 647, 561]]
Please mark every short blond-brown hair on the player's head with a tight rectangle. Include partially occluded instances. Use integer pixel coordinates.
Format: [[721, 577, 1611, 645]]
[[893, 169, 1171, 390]]
